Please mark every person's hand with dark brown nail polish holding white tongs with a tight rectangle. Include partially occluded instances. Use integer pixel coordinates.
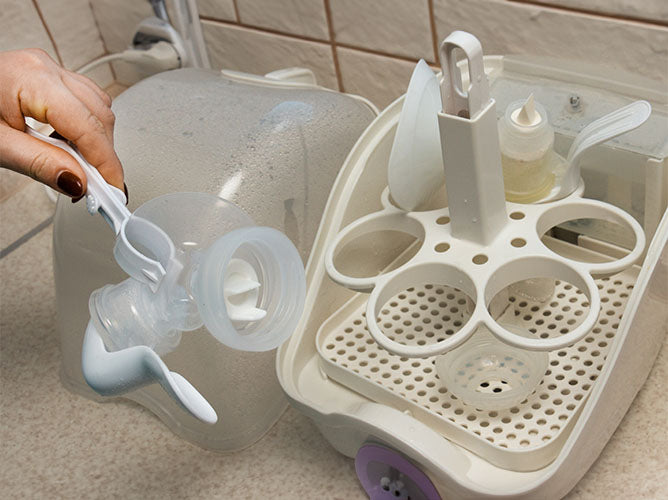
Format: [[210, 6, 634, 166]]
[[0, 49, 127, 201]]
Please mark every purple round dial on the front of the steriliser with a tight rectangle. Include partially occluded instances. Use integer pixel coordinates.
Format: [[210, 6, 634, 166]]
[[355, 444, 441, 500]]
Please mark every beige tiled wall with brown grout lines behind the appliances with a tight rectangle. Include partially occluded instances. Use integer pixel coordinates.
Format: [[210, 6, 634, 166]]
[[0, 0, 668, 107]]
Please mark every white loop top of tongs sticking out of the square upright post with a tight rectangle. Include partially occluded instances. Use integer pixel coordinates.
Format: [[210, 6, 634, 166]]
[[440, 31, 489, 119]]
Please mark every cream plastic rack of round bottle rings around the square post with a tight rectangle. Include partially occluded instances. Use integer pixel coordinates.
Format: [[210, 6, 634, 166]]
[[325, 196, 645, 358]]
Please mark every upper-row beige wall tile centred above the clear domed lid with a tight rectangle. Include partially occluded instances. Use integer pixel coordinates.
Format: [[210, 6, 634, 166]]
[[237, 0, 329, 40]]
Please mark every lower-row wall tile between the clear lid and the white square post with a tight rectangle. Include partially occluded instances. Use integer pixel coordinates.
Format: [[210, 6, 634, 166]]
[[337, 48, 415, 109]]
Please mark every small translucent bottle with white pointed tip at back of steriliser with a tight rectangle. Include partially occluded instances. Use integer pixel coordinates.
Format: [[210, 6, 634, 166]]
[[499, 94, 554, 203]]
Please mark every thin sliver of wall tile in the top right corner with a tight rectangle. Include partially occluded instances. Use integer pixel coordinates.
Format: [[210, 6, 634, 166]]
[[529, 0, 668, 22]]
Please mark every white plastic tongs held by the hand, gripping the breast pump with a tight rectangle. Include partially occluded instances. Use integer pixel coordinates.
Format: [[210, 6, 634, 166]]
[[26, 125, 174, 292]]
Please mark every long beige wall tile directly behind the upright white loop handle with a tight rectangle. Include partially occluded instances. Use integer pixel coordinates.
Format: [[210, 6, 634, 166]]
[[434, 0, 668, 82]]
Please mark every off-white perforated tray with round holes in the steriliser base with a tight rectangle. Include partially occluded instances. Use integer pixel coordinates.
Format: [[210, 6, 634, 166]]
[[316, 269, 637, 471]]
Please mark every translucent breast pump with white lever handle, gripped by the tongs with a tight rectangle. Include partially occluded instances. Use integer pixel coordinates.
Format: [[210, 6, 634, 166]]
[[82, 193, 305, 423]]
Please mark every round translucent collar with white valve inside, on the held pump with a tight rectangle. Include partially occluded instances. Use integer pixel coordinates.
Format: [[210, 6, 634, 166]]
[[192, 226, 306, 351]]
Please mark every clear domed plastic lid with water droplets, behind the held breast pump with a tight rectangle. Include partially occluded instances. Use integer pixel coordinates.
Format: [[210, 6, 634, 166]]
[[54, 69, 375, 451]]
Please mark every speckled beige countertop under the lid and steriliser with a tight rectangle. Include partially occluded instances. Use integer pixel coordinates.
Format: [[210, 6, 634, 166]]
[[0, 171, 668, 499]]
